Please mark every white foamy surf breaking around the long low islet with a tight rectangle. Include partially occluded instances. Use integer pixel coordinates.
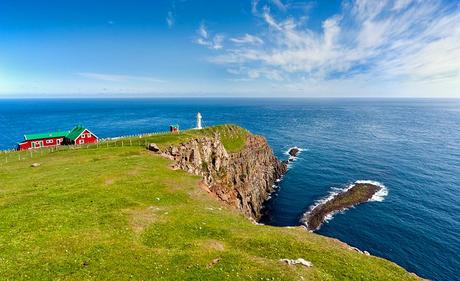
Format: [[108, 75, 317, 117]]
[[300, 180, 388, 232]]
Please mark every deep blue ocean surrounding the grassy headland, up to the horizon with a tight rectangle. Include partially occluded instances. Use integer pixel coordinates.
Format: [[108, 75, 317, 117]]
[[0, 98, 460, 280]]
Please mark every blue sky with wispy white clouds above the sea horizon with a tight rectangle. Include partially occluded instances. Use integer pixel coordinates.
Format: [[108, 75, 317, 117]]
[[0, 0, 460, 97]]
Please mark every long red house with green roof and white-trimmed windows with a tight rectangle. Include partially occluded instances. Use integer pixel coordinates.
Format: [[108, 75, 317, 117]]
[[18, 125, 98, 150]]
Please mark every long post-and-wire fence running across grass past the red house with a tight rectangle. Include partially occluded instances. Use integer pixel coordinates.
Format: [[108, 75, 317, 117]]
[[0, 131, 175, 167]]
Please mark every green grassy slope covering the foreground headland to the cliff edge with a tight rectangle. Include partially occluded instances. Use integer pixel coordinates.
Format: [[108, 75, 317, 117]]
[[0, 128, 413, 280]]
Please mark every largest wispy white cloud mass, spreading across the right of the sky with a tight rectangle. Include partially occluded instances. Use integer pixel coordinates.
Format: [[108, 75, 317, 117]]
[[205, 0, 460, 92]]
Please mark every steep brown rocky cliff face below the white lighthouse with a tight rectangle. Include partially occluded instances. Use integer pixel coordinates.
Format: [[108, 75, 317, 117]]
[[161, 134, 287, 220]]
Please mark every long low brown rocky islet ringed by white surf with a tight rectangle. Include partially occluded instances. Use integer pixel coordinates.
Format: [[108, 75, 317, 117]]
[[301, 182, 383, 231]]
